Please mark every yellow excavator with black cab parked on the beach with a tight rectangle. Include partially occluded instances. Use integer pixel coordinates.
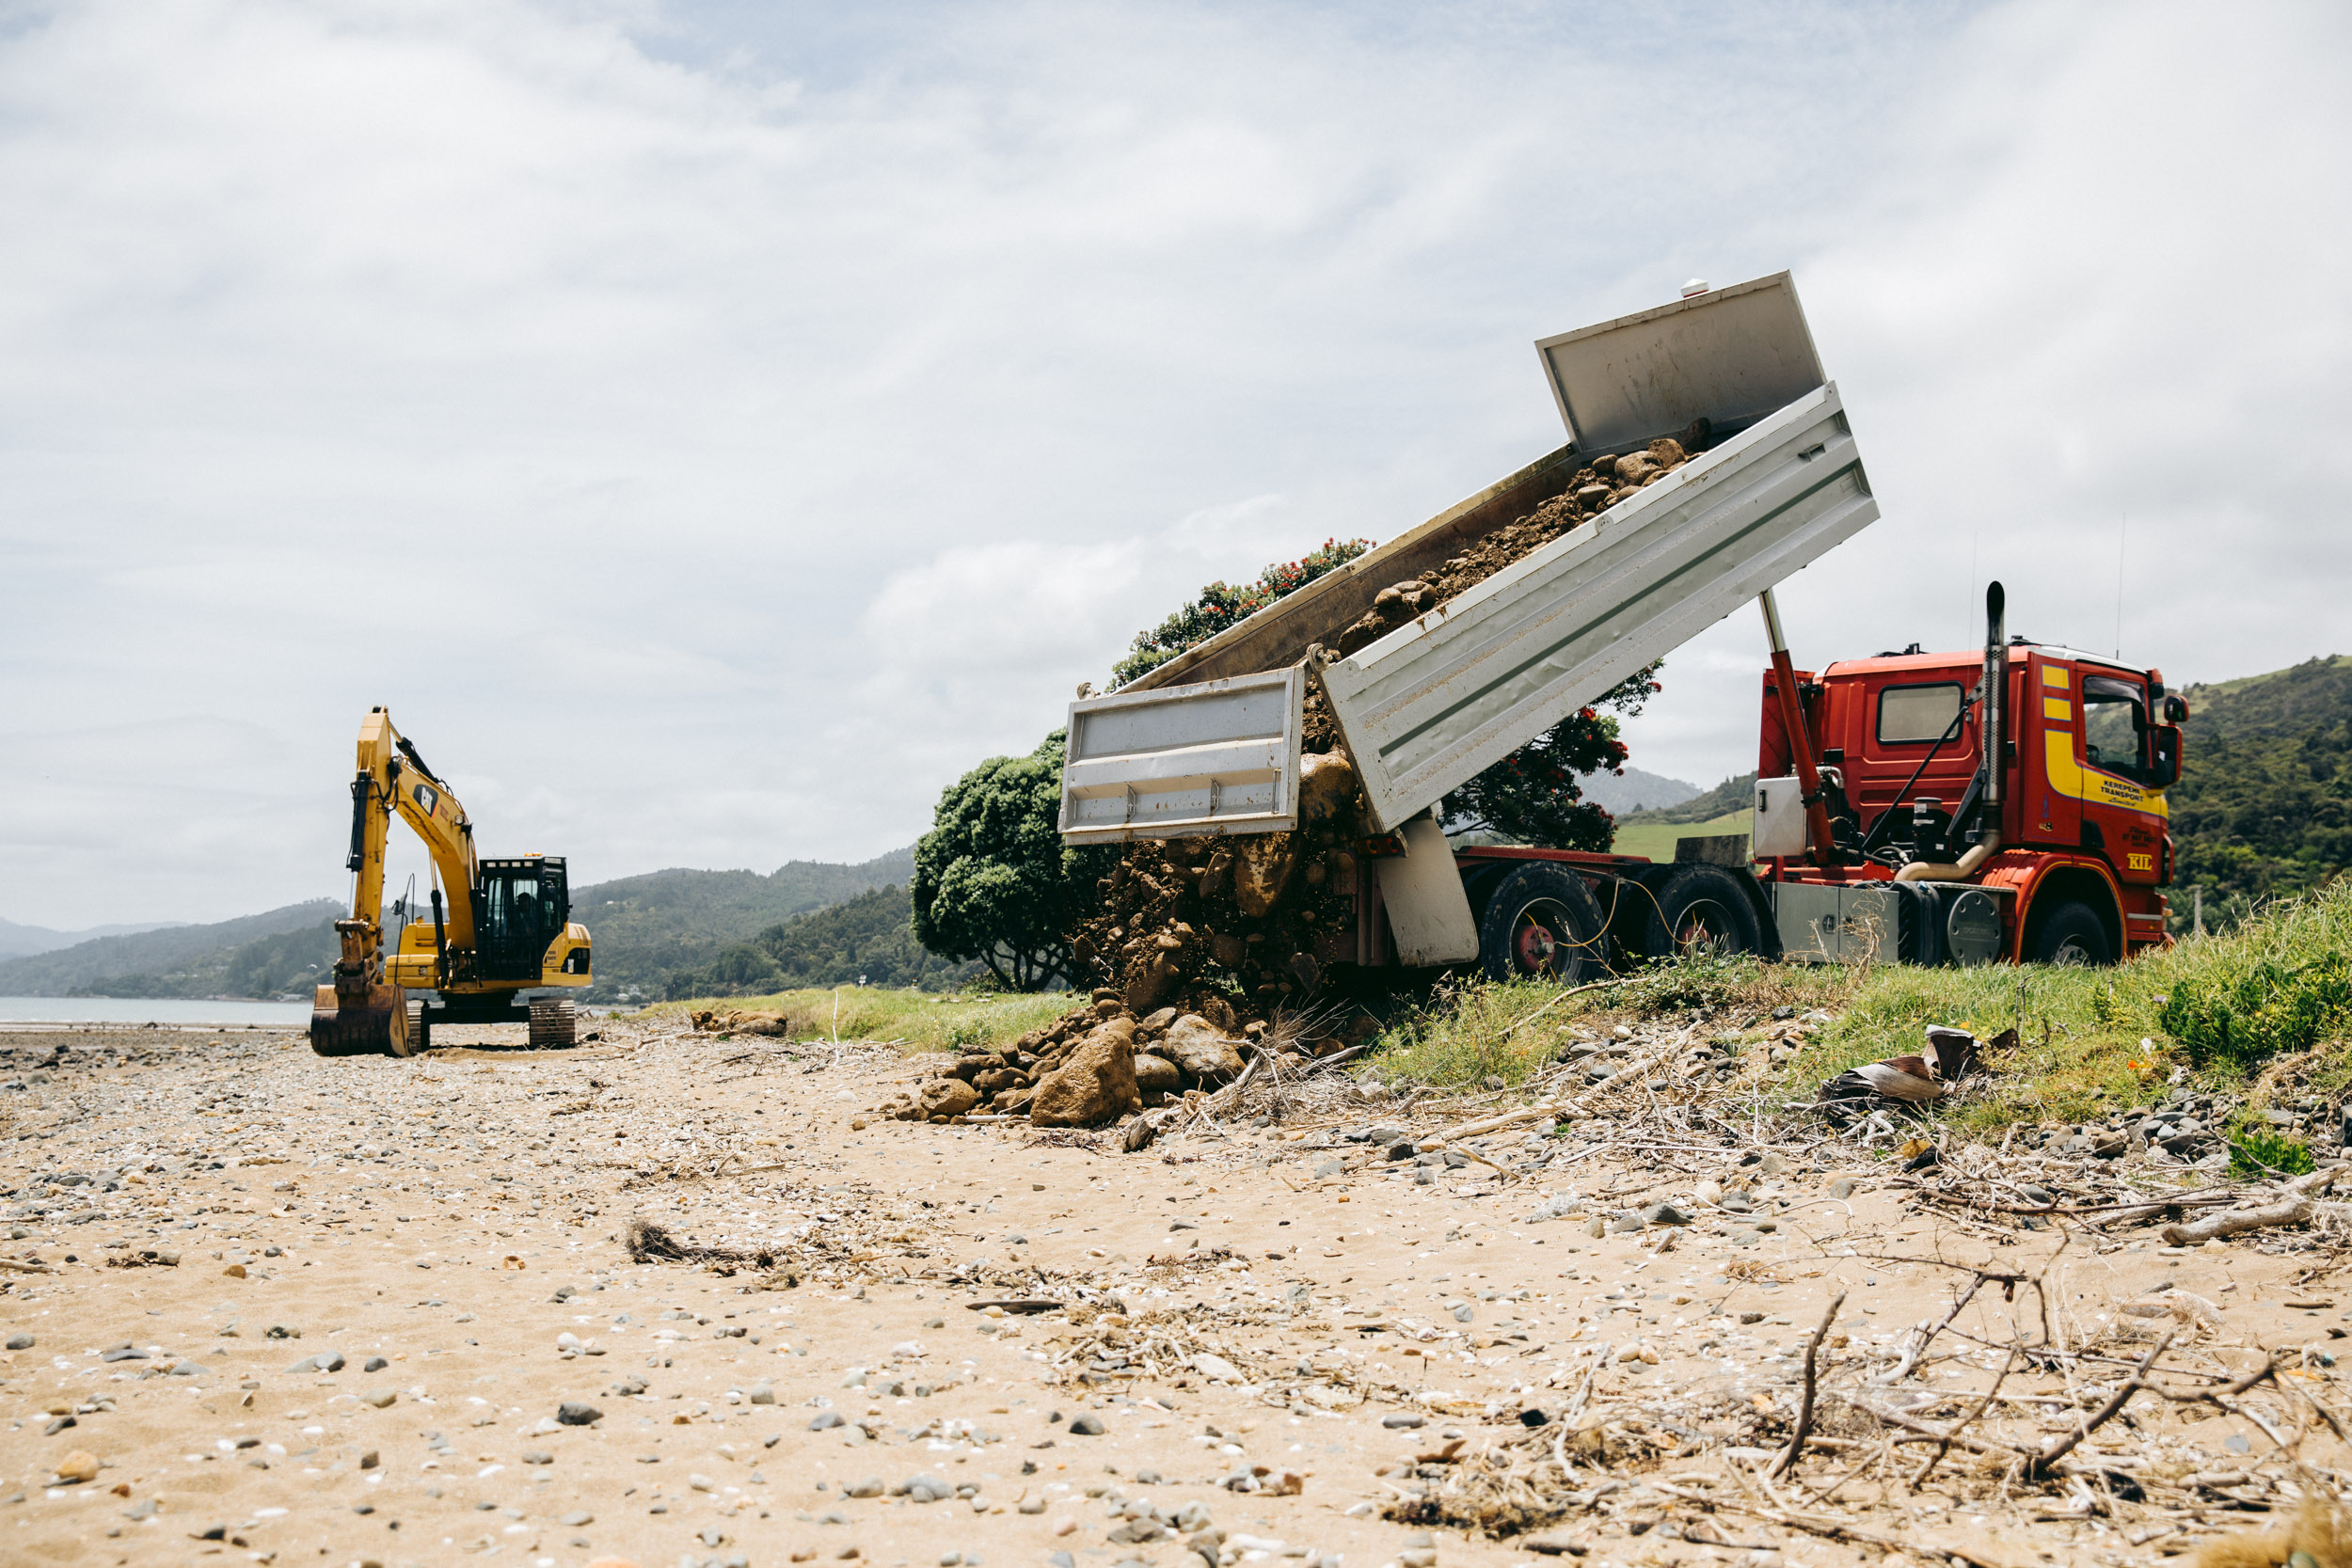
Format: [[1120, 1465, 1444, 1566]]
[[310, 707, 593, 1055]]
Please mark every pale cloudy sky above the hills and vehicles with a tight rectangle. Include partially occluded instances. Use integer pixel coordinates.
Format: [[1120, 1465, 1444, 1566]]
[[0, 0, 2352, 928]]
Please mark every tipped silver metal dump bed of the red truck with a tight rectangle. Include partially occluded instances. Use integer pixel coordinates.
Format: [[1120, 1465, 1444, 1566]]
[[1061, 273, 1877, 842]]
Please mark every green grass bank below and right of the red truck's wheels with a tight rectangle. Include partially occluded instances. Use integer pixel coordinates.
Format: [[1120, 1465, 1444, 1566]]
[[1369, 881, 2352, 1133]]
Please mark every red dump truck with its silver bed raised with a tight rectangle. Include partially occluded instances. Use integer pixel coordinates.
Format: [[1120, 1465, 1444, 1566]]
[[1061, 273, 2187, 980]]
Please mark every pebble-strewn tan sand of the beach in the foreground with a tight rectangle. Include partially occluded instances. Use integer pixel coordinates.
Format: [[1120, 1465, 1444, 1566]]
[[0, 1022, 2352, 1568]]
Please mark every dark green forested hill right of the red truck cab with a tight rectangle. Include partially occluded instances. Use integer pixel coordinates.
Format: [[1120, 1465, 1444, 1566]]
[[2169, 656, 2352, 927]]
